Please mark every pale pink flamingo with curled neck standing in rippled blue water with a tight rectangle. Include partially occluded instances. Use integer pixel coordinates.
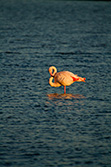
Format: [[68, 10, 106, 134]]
[[49, 66, 86, 94]]
